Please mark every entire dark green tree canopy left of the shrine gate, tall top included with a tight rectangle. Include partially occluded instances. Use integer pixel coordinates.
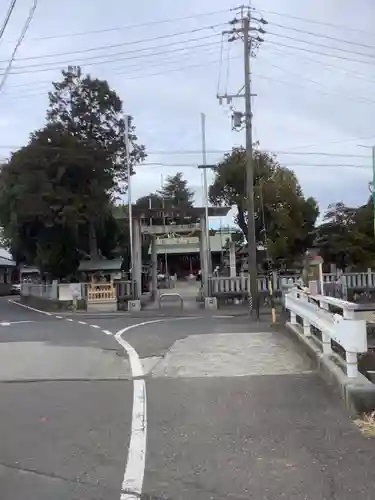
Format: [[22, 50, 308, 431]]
[[0, 68, 145, 278]]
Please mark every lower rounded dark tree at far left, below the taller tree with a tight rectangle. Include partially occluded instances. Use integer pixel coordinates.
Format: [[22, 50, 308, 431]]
[[0, 125, 113, 278]]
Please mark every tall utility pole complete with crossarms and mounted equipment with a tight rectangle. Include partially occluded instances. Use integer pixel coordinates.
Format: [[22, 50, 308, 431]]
[[217, 6, 267, 316]]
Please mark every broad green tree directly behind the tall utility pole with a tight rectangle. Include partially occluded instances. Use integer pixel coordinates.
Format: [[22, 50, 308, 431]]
[[209, 148, 319, 264]]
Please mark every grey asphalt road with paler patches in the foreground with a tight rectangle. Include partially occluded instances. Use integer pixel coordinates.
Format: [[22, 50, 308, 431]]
[[0, 299, 375, 500]]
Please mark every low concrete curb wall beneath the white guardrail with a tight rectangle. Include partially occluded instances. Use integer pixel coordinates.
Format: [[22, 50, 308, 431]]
[[286, 322, 375, 416]]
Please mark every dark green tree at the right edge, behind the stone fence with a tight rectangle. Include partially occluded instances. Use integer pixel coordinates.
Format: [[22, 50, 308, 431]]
[[316, 199, 375, 270]]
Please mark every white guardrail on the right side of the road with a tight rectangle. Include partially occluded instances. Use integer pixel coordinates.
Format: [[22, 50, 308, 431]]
[[285, 287, 367, 378]]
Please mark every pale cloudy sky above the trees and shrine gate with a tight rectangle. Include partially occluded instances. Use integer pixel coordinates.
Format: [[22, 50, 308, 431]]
[[0, 0, 375, 229]]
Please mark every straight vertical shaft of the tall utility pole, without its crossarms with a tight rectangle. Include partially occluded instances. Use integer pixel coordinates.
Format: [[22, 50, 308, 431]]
[[243, 11, 259, 315]]
